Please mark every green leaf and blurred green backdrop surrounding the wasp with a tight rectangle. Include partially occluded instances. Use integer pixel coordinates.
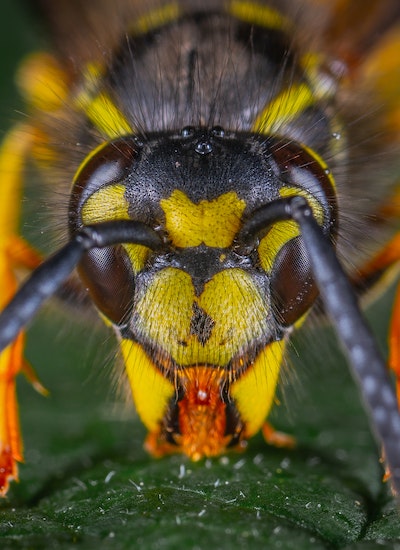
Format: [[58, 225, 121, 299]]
[[0, 0, 400, 550]]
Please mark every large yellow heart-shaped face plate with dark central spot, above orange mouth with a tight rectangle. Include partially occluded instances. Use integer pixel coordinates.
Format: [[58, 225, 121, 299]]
[[136, 268, 268, 366]]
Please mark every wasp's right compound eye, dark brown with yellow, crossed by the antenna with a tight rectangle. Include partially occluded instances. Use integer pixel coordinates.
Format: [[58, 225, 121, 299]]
[[258, 142, 337, 326]]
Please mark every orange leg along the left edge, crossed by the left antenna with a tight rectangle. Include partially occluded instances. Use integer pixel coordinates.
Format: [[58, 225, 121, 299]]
[[0, 125, 45, 496]]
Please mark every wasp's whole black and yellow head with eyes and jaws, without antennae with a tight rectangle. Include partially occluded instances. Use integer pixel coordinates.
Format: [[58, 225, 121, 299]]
[[71, 127, 335, 458]]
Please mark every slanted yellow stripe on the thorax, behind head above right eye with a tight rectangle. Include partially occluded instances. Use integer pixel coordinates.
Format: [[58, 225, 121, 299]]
[[253, 83, 315, 134]]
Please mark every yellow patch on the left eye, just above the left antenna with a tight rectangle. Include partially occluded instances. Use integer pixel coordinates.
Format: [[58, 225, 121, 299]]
[[82, 184, 130, 225]]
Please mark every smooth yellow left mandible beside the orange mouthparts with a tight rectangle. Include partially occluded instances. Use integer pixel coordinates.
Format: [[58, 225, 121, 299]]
[[121, 340, 175, 431]]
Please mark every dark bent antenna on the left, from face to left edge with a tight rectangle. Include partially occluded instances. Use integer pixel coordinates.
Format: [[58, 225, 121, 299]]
[[0, 220, 162, 351]]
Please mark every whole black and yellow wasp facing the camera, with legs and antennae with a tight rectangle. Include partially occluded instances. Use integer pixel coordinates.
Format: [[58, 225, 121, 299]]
[[0, 0, 400, 495]]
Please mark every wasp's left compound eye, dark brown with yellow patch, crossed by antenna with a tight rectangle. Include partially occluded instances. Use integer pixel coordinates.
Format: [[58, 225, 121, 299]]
[[69, 137, 140, 325]]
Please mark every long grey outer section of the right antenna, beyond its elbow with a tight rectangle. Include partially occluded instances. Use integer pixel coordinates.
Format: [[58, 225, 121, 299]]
[[290, 197, 400, 494]]
